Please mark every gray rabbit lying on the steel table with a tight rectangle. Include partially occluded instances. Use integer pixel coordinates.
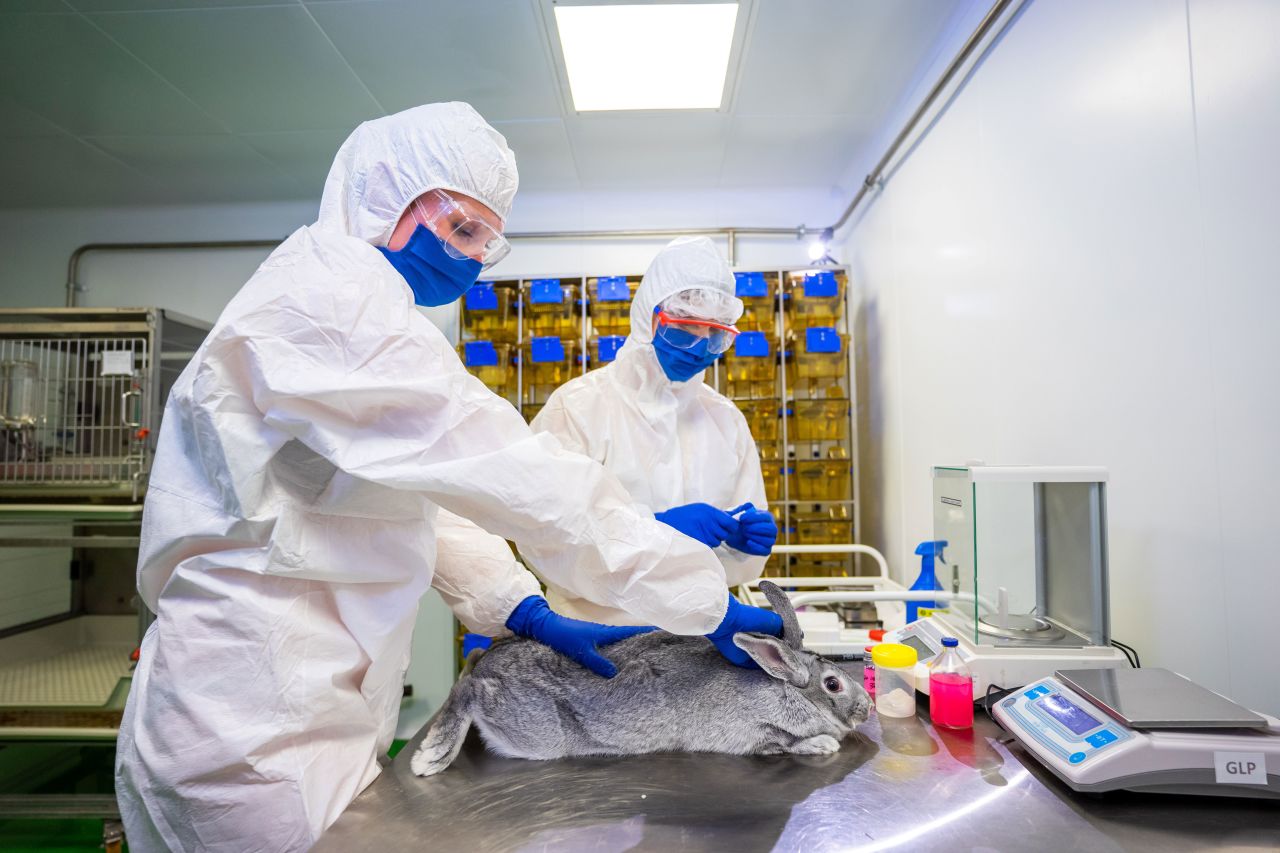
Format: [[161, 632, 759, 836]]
[[410, 580, 870, 776]]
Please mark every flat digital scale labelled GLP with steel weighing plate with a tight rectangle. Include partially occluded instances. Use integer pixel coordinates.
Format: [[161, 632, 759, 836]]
[[992, 669, 1280, 799]]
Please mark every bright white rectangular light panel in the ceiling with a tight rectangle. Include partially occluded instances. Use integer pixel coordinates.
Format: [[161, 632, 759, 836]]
[[556, 3, 739, 113]]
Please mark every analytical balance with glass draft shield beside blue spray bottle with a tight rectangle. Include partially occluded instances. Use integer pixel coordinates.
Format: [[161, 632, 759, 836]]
[[884, 466, 1129, 699]]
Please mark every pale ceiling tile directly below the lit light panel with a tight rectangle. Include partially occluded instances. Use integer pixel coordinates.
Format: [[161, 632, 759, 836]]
[[564, 113, 728, 190]]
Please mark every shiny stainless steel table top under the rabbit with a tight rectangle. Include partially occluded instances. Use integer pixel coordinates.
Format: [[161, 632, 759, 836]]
[[315, 666, 1280, 853]]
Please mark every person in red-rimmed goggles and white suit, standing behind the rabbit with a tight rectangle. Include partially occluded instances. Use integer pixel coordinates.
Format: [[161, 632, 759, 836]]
[[532, 237, 778, 625]]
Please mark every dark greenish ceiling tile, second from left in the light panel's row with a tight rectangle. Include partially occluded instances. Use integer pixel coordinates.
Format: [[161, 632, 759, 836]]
[[92, 5, 381, 133]]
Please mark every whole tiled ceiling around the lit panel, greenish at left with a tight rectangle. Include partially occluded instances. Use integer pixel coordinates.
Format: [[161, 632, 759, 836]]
[[0, 0, 972, 207]]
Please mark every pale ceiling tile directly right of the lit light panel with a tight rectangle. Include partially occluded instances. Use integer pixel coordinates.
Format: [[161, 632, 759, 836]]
[[733, 0, 964, 119]]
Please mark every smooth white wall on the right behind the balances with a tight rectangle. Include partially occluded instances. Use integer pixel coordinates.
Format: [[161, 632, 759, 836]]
[[845, 0, 1280, 713]]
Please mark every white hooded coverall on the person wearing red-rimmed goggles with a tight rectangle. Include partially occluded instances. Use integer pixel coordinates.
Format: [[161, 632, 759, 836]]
[[530, 237, 767, 625]]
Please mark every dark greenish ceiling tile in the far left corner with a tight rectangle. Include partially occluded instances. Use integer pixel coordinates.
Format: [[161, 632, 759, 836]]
[[0, 14, 218, 134]]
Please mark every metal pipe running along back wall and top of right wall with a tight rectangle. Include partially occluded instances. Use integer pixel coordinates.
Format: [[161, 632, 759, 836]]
[[67, 0, 1028, 307]]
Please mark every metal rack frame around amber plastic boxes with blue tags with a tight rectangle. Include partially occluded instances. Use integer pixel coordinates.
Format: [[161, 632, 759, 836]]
[[457, 266, 861, 575]]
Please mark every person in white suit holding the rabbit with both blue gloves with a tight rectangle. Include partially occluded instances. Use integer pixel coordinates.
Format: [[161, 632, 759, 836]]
[[116, 104, 781, 853]]
